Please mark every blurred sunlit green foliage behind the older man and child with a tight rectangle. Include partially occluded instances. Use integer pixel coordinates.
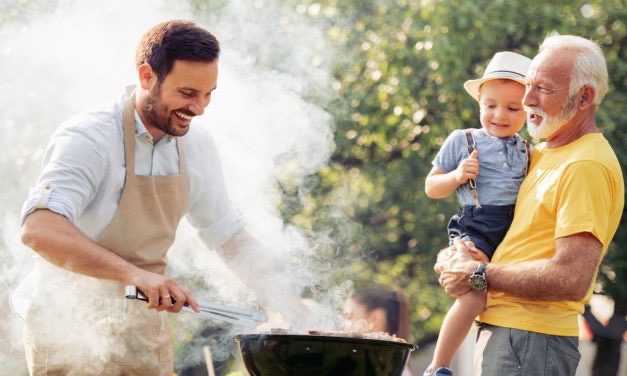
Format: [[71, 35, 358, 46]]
[[284, 0, 627, 341]]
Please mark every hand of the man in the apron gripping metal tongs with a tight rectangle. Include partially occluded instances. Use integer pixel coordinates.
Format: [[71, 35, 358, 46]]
[[130, 268, 200, 313]]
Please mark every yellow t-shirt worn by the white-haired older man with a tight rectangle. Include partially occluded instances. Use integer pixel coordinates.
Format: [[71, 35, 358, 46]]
[[480, 133, 624, 336]]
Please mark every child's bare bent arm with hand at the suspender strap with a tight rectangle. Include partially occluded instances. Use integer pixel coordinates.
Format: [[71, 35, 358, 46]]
[[425, 150, 479, 199]]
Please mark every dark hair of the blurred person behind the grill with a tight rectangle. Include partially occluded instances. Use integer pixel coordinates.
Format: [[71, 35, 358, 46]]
[[353, 286, 409, 341]]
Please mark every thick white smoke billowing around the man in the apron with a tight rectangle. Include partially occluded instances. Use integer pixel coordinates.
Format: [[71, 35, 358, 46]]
[[0, 0, 350, 375]]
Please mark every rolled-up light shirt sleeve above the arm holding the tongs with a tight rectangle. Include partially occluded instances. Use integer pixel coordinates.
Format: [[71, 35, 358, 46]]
[[21, 119, 106, 223]]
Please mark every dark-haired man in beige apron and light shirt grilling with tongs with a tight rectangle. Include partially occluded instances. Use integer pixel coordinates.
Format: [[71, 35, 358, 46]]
[[14, 20, 300, 375]]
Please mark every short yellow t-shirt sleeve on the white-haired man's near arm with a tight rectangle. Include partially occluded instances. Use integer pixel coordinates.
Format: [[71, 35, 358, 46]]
[[555, 161, 615, 247]]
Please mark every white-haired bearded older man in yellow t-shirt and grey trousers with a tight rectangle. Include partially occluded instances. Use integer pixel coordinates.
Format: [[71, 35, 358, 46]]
[[440, 35, 624, 376]]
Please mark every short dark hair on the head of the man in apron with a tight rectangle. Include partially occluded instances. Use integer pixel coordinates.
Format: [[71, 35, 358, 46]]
[[135, 20, 220, 82]]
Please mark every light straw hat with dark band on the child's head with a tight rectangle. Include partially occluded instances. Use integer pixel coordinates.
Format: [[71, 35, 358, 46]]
[[464, 51, 531, 101]]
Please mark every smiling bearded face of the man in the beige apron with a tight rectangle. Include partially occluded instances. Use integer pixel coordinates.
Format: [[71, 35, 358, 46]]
[[138, 60, 218, 143]]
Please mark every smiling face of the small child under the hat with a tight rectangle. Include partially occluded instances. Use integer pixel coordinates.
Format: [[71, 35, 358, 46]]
[[479, 79, 527, 137]]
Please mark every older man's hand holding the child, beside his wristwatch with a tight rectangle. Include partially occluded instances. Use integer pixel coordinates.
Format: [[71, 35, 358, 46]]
[[436, 238, 479, 297]]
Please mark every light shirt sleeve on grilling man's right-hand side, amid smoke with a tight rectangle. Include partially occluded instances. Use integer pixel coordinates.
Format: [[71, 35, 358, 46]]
[[186, 134, 244, 249]]
